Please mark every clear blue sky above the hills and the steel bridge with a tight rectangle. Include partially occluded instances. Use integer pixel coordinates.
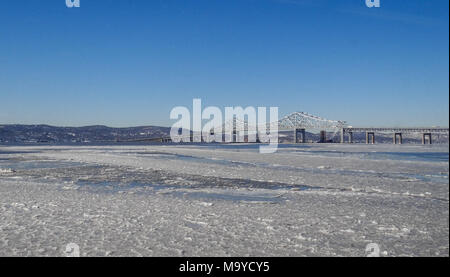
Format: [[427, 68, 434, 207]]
[[0, 0, 449, 127]]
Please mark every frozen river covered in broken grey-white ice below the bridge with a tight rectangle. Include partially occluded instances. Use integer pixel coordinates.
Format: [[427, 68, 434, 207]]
[[0, 144, 449, 256]]
